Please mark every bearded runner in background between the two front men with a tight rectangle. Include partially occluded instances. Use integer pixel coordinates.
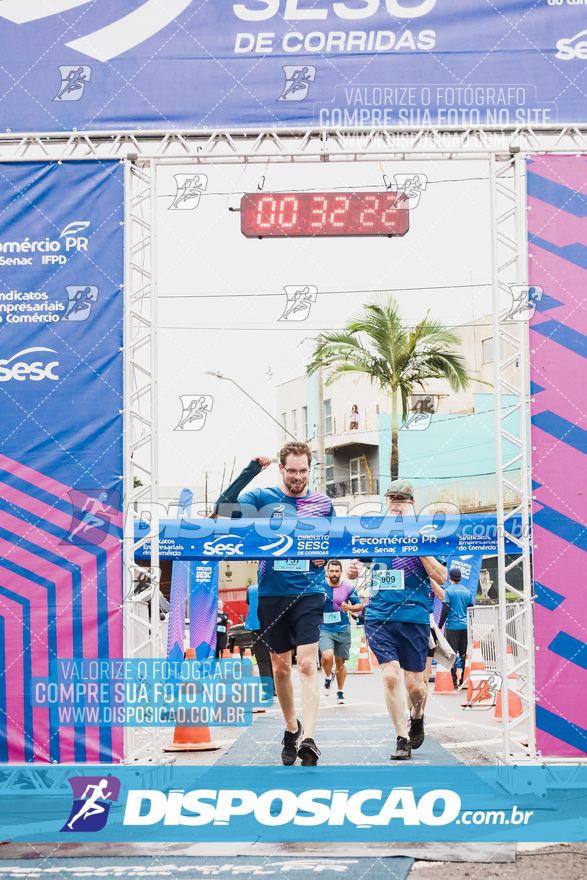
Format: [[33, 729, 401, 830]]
[[318, 559, 363, 705]]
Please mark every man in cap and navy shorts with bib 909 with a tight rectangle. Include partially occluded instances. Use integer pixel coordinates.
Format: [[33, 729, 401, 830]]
[[348, 480, 447, 761]]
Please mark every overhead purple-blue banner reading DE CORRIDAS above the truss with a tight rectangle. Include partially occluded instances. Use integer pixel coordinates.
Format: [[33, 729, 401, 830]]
[[0, 0, 587, 131]]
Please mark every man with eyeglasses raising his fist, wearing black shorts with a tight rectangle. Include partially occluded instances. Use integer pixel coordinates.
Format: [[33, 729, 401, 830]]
[[214, 441, 335, 767]]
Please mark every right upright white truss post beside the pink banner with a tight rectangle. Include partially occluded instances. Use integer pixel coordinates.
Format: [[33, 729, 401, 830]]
[[489, 154, 536, 764]]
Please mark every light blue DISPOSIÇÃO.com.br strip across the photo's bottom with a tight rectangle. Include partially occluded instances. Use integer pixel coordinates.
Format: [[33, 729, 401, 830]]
[[0, 765, 587, 844]]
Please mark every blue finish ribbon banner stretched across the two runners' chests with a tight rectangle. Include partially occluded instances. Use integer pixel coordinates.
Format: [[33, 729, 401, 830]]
[[135, 514, 522, 559]]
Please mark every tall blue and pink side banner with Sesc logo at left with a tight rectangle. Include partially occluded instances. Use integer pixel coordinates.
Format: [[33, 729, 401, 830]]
[[0, 163, 124, 763]]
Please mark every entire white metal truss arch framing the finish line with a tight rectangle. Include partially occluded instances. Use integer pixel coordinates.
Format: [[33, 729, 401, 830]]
[[0, 125, 587, 764]]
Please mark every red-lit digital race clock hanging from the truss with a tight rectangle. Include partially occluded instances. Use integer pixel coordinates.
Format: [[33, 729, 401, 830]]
[[241, 192, 409, 238]]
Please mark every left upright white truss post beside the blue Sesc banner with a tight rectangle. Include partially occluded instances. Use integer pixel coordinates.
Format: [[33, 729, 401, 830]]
[[123, 160, 161, 763]]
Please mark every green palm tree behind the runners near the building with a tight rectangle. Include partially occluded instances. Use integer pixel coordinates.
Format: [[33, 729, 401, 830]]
[[307, 297, 471, 480]]
